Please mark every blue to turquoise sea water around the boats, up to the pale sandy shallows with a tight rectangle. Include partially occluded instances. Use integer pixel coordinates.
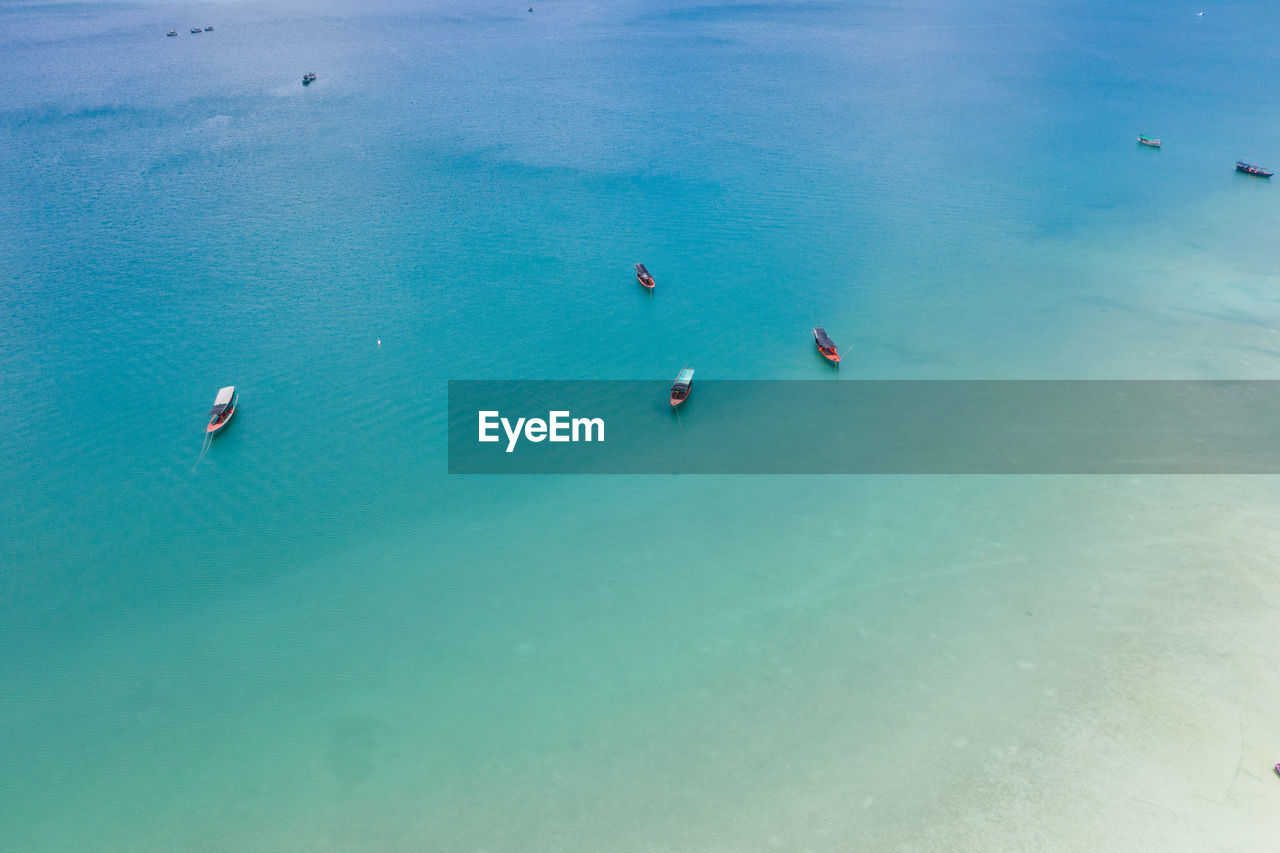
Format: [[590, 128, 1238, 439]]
[[0, 0, 1280, 850]]
